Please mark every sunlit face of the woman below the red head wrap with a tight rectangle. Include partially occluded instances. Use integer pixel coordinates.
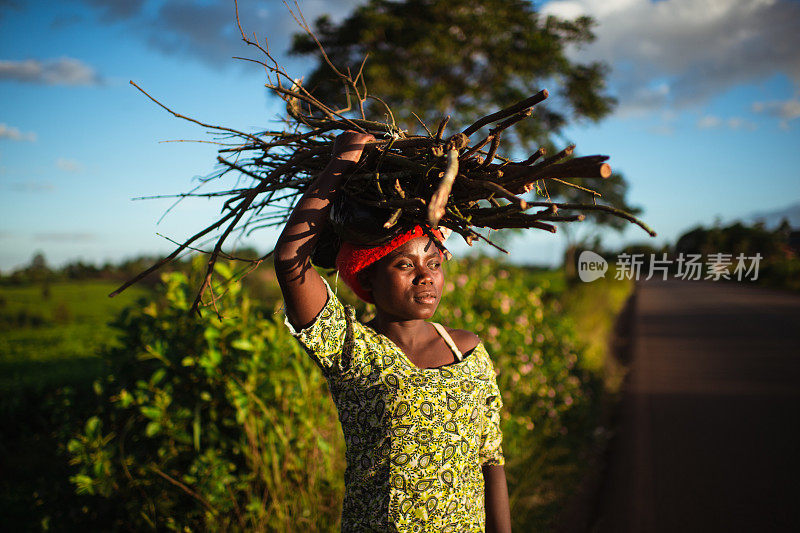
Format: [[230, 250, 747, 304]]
[[360, 236, 444, 320]]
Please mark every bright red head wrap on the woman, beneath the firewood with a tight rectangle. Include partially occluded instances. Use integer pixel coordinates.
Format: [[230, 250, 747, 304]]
[[336, 225, 450, 303]]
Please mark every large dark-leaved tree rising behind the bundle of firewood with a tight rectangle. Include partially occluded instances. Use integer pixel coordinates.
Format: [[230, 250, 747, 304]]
[[291, 0, 640, 266]]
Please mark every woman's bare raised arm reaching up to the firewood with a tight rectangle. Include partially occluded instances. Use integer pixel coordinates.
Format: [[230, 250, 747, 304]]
[[275, 131, 374, 329]]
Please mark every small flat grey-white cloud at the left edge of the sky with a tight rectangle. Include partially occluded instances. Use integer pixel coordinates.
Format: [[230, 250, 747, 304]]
[[0, 57, 103, 85]]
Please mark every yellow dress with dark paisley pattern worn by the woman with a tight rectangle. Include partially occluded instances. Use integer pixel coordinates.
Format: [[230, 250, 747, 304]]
[[286, 283, 505, 533]]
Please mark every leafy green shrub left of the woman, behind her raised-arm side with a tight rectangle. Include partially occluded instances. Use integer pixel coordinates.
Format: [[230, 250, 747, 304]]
[[68, 265, 343, 531]]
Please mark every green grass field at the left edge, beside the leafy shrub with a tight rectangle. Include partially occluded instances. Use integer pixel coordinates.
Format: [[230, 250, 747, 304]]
[[0, 281, 146, 531]]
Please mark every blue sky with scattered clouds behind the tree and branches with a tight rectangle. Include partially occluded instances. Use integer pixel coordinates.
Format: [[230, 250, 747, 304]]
[[0, 0, 800, 272]]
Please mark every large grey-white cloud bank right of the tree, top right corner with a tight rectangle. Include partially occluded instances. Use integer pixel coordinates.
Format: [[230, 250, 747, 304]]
[[542, 0, 800, 115]]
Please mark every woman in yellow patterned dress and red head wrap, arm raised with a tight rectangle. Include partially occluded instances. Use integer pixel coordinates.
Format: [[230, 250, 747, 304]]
[[275, 132, 511, 533]]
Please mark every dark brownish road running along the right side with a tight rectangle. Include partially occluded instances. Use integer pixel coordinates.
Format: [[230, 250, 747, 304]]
[[591, 280, 800, 533]]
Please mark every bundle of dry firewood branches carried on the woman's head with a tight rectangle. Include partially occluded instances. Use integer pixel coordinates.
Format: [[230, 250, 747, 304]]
[[112, 2, 655, 310]]
